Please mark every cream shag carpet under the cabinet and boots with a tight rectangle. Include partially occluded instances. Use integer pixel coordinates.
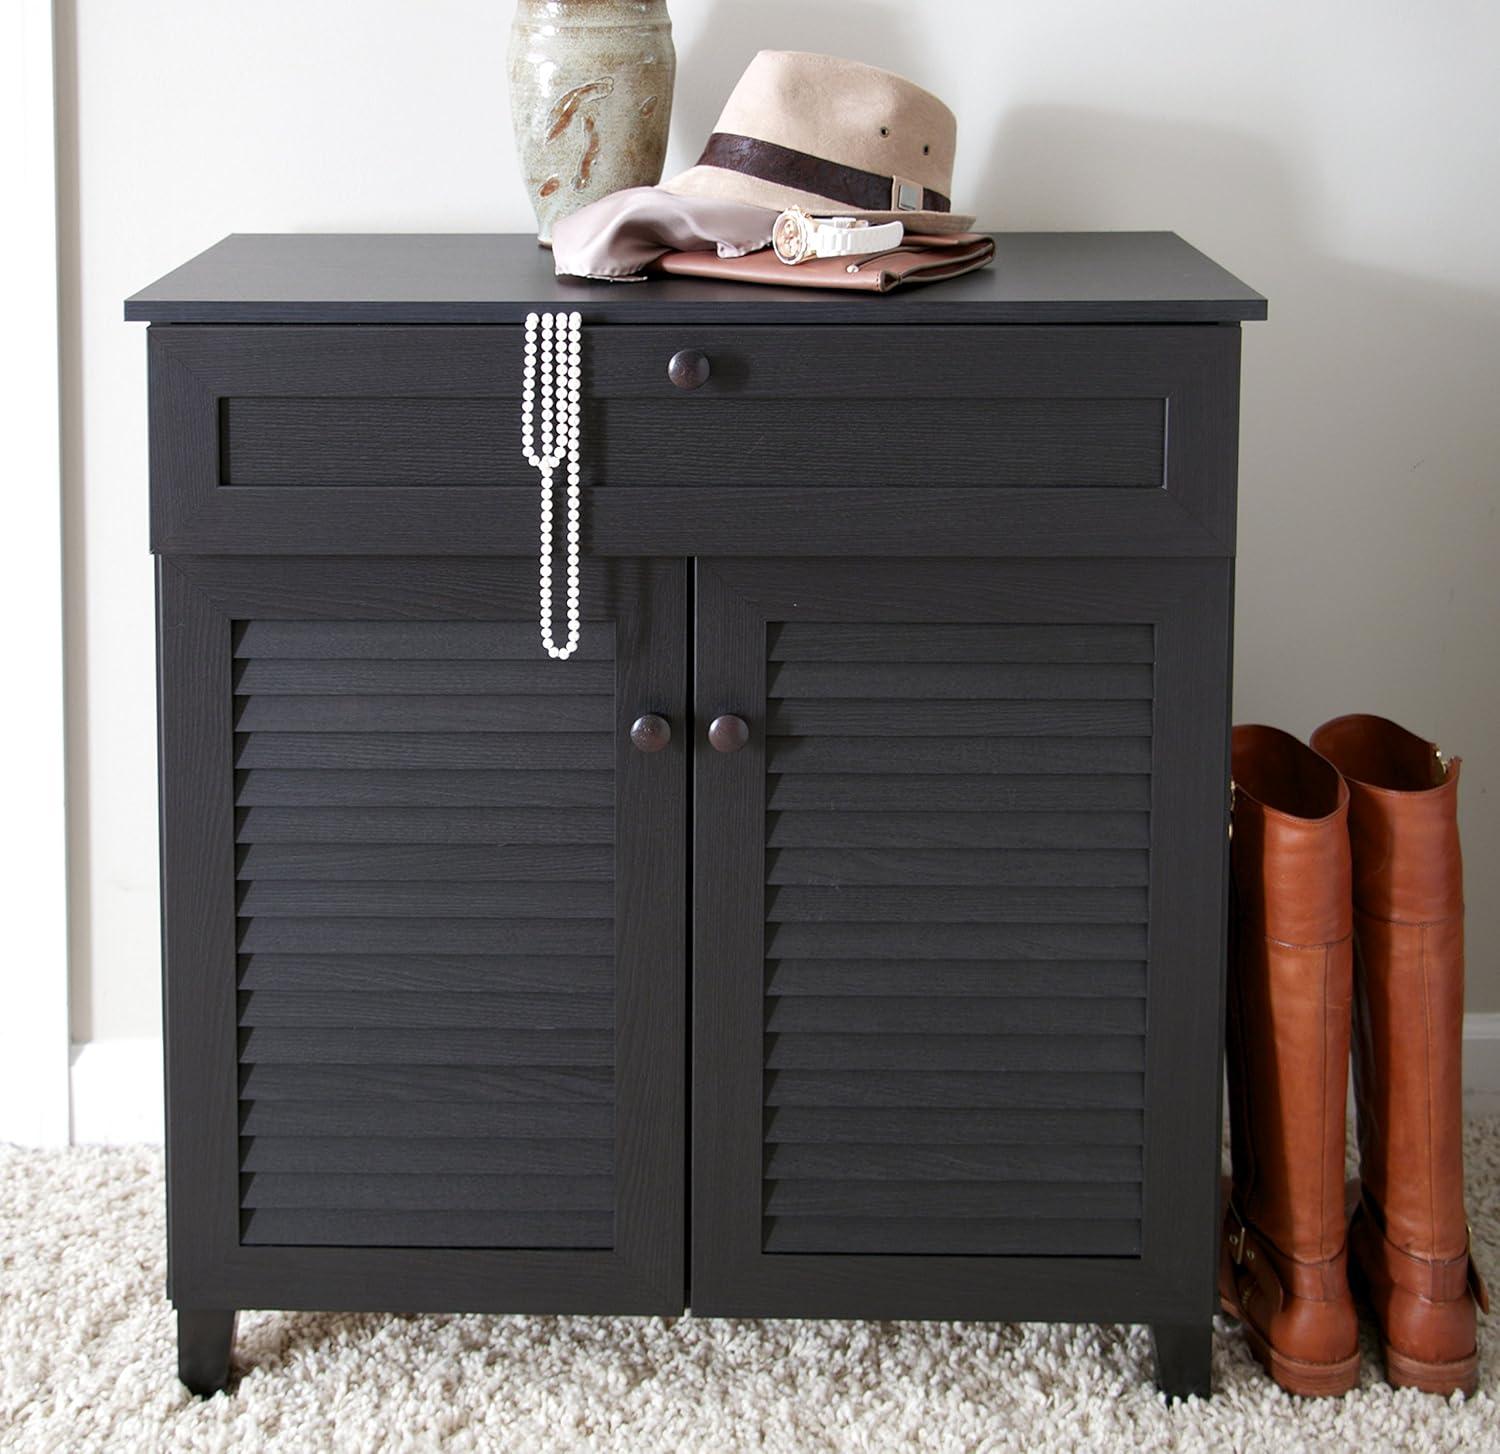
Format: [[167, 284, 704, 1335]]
[[0, 1118, 1500, 1454]]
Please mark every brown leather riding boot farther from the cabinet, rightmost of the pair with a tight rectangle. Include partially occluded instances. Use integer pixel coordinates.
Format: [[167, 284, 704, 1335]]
[[1313, 716, 1490, 1394]]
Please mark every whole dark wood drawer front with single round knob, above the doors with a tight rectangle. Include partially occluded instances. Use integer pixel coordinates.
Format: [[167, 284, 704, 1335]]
[[152, 321, 1238, 555]]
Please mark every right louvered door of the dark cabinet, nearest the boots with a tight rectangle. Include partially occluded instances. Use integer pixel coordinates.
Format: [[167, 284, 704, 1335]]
[[692, 560, 1230, 1323]]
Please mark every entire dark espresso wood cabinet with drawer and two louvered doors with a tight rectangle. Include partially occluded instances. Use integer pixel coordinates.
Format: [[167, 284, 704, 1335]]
[[126, 234, 1265, 1394]]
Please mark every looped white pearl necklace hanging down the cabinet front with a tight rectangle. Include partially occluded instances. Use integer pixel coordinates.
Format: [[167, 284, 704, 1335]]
[[521, 314, 582, 662]]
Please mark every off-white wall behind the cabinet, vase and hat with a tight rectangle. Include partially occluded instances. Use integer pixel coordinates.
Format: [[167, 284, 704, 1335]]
[[60, 0, 1500, 1040]]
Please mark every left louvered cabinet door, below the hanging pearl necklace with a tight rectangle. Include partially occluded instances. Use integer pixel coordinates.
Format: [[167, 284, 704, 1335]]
[[159, 558, 686, 1313]]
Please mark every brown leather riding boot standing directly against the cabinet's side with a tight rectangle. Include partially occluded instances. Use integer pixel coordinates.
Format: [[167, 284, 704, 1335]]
[[1220, 726, 1359, 1394]]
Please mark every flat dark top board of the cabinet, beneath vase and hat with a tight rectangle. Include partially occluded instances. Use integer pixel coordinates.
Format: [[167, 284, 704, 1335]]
[[125, 233, 1266, 324]]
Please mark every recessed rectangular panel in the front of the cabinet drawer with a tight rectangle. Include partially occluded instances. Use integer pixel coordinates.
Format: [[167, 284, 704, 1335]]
[[219, 390, 1167, 489]]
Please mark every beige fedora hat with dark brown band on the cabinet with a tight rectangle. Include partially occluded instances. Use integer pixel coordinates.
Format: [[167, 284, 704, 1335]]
[[662, 51, 974, 233]]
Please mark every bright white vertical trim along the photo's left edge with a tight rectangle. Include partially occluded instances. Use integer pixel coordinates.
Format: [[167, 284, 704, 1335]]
[[0, 0, 69, 1145]]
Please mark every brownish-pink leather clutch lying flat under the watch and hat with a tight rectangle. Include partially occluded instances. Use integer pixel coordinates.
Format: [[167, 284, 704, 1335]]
[[648, 233, 995, 293]]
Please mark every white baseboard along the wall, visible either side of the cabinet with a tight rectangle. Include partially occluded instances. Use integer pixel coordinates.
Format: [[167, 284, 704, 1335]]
[[55, 1014, 1500, 1146]]
